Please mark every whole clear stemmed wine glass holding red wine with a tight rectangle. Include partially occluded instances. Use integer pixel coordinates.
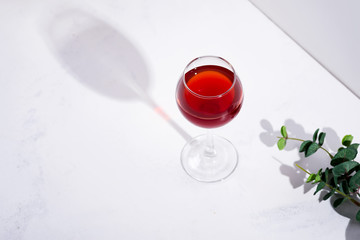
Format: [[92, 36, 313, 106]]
[[176, 56, 243, 182]]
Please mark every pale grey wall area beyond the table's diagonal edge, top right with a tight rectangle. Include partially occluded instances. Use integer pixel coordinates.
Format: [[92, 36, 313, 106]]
[[251, 0, 360, 98]]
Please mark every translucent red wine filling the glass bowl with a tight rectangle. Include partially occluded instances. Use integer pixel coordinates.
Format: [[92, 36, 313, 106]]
[[177, 65, 243, 128]]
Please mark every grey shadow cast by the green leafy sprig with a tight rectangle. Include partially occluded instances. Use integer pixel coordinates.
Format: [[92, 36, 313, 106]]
[[259, 119, 360, 240]]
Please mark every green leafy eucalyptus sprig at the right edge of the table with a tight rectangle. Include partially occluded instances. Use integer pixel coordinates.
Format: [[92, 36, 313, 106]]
[[277, 126, 360, 222]]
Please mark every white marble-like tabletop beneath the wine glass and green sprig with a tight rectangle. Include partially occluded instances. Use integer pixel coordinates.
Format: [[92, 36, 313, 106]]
[[0, 0, 360, 240]]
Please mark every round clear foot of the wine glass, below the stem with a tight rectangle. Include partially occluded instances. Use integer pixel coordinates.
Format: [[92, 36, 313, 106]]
[[181, 135, 238, 182]]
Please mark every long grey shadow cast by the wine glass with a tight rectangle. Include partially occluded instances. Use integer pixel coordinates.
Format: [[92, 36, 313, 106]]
[[46, 9, 191, 141]]
